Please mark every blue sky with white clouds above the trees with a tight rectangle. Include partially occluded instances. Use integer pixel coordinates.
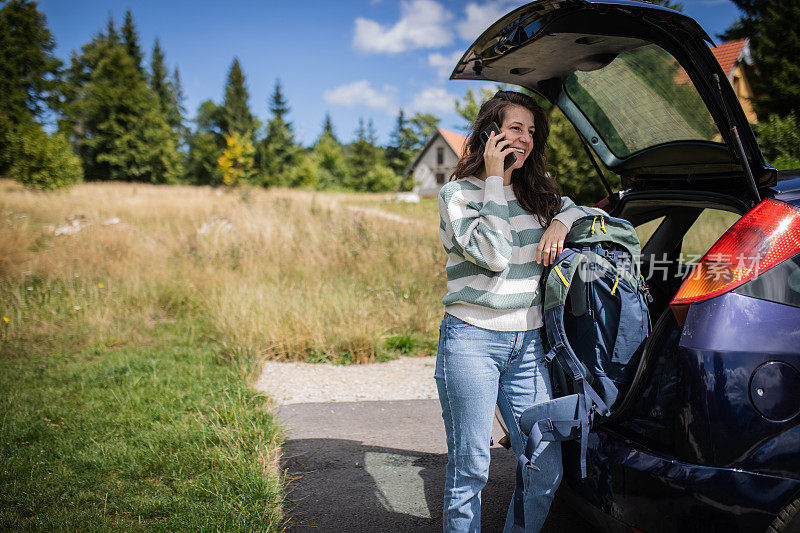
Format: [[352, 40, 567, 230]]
[[39, 0, 738, 145]]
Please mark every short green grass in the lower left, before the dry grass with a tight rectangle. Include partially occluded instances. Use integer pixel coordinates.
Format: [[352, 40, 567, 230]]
[[0, 323, 283, 531]]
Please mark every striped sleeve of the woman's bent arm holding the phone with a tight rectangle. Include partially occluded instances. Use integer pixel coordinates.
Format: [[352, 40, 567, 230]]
[[439, 176, 513, 272]]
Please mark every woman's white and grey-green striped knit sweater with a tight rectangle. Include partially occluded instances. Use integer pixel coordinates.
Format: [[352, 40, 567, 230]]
[[439, 176, 602, 331]]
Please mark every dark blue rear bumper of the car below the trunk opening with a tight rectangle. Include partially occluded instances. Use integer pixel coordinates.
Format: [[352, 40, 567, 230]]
[[560, 429, 800, 533]]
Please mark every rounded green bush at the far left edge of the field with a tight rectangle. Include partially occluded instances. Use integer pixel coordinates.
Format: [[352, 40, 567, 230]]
[[6, 124, 83, 190]]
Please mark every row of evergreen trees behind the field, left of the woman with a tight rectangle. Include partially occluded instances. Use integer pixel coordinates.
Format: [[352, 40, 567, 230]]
[[0, 0, 439, 191]]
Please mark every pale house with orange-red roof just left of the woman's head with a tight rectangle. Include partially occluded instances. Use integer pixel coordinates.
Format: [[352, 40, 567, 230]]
[[405, 128, 467, 196]]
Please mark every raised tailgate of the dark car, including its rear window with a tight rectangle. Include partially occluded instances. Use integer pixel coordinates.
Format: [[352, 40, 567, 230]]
[[451, 0, 775, 205]]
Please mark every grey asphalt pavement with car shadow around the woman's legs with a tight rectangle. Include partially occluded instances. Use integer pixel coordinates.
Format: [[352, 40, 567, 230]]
[[278, 400, 591, 533]]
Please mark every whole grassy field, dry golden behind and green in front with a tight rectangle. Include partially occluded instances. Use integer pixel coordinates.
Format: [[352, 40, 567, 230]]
[[0, 181, 444, 531]]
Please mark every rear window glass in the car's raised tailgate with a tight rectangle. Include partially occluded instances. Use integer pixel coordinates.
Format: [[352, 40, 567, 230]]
[[564, 44, 722, 158]]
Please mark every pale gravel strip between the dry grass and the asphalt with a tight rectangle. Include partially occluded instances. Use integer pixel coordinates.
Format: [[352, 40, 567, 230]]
[[256, 357, 438, 405]]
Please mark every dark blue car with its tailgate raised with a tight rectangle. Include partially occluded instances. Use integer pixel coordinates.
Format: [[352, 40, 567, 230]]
[[450, 0, 800, 533]]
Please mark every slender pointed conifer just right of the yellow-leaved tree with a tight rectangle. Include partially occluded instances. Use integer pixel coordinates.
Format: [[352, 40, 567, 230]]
[[259, 80, 298, 186]]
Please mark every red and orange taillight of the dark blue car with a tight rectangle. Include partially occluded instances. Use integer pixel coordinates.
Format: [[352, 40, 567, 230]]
[[669, 199, 800, 325]]
